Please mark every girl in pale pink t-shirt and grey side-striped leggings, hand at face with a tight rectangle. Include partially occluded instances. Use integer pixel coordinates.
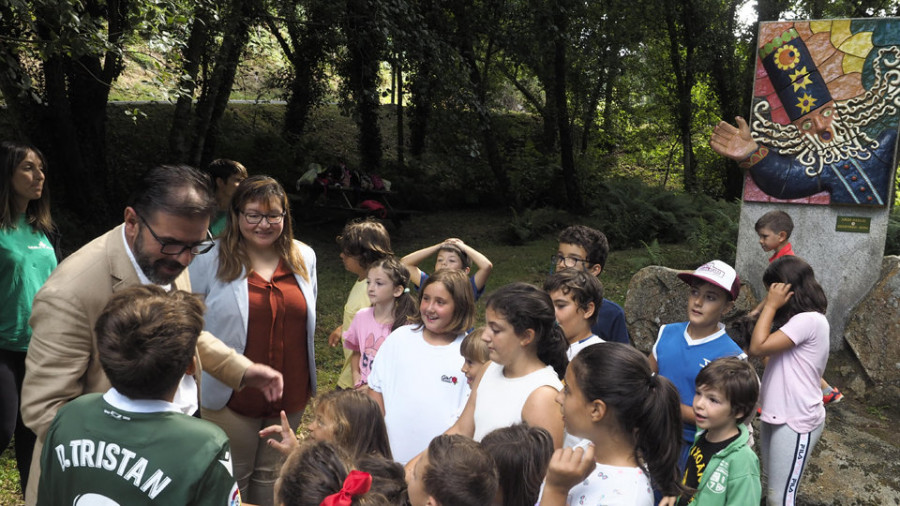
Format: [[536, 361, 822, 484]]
[[750, 256, 830, 506]]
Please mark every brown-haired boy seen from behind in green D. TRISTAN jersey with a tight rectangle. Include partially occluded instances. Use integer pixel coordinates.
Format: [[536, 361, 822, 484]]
[[38, 285, 241, 505]]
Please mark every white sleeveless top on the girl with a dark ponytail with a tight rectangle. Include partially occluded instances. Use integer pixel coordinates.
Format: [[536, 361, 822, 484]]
[[473, 362, 562, 441]]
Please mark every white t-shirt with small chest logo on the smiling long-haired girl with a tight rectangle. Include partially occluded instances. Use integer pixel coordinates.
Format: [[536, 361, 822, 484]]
[[369, 325, 469, 464]]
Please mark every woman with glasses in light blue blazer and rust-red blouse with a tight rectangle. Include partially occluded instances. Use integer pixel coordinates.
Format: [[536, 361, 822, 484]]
[[190, 176, 318, 505]]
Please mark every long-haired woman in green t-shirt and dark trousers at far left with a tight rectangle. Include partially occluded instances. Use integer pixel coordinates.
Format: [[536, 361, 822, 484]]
[[0, 142, 56, 491]]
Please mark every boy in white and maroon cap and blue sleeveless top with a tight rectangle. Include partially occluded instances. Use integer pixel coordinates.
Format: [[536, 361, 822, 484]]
[[650, 260, 747, 471]]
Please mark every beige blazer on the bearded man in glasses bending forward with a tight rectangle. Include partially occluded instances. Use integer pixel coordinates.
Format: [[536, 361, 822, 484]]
[[22, 225, 251, 505]]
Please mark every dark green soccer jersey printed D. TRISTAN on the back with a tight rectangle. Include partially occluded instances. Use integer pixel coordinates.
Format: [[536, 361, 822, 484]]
[[38, 393, 241, 506]]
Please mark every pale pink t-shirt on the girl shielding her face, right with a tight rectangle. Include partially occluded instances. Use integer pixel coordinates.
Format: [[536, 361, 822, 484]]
[[760, 312, 830, 434]]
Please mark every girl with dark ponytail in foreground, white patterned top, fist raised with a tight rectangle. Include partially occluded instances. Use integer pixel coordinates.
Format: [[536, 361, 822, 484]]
[[540, 343, 685, 506]]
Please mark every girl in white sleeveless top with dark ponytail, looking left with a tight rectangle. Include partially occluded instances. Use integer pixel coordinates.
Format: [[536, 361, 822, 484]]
[[447, 283, 568, 448]]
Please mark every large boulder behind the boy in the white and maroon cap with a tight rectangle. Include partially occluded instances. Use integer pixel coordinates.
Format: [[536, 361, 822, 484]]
[[625, 265, 758, 353]]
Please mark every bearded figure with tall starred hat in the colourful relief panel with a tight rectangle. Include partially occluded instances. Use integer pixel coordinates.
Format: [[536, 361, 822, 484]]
[[710, 28, 900, 206]]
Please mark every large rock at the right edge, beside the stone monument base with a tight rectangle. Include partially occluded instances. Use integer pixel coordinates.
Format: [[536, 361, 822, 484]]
[[844, 256, 900, 403]]
